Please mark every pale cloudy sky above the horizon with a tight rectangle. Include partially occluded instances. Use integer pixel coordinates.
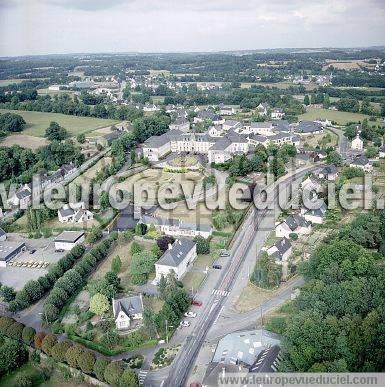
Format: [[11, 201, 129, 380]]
[[0, 0, 385, 56]]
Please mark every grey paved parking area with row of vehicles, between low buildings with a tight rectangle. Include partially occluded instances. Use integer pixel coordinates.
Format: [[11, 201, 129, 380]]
[[0, 233, 66, 291]]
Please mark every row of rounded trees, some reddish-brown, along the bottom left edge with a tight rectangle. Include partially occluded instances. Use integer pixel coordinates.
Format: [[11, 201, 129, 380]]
[[0, 317, 139, 387]]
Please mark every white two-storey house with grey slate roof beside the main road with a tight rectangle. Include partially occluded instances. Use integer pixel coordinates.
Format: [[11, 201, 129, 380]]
[[154, 237, 197, 283]]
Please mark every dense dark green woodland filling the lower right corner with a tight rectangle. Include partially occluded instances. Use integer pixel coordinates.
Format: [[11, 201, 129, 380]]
[[281, 211, 385, 372]]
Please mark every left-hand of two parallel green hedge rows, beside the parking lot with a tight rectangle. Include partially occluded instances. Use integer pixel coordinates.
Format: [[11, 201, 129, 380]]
[[8, 245, 85, 312]]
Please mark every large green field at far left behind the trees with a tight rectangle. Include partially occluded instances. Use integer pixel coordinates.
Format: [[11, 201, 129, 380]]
[[0, 109, 118, 137]]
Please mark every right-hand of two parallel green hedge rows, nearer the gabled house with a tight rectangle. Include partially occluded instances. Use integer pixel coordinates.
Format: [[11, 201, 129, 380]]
[[43, 233, 118, 322]]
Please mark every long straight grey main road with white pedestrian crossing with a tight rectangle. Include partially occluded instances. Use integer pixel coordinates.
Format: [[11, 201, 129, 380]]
[[160, 167, 317, 386]]
